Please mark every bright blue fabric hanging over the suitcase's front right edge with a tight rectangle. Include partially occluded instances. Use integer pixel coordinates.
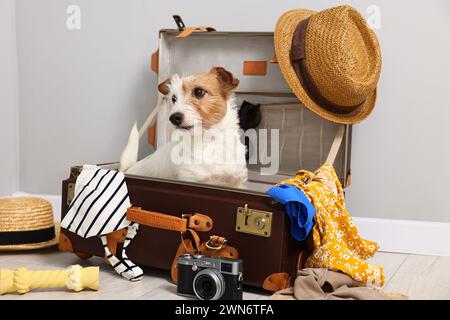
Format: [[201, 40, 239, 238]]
[[267, 184, 316, 241]]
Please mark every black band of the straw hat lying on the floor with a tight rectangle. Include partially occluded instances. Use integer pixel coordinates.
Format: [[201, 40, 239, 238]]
[[0, 226, 55, 246]]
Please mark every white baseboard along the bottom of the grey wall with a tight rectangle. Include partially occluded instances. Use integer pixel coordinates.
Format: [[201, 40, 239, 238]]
[[13, 192, 450, 256]]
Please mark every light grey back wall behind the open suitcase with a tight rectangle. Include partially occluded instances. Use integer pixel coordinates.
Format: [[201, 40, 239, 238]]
[[12, 0, 450, 222]]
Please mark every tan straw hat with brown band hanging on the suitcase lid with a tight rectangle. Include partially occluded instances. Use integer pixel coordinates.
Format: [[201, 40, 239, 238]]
[[274, 6, 381, 124]]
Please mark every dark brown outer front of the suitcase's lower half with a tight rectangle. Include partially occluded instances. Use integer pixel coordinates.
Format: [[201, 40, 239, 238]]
[[60, 167, 303, 287]]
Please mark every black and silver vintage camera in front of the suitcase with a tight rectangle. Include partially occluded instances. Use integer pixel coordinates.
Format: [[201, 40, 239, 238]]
[[177, 253, 242, 300]]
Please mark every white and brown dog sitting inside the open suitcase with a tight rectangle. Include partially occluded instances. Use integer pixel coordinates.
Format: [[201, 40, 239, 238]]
[[120, 67, 247, 187]]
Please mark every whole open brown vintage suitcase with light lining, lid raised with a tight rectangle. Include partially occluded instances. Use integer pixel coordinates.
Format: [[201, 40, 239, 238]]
[[60, 30, 351, 290]]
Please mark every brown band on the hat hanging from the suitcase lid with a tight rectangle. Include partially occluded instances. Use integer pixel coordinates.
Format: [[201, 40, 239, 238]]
[[291, 17, 365, 114]]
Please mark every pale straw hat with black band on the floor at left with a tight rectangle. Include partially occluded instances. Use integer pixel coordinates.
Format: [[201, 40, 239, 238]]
[[0, 197, 60, 251]]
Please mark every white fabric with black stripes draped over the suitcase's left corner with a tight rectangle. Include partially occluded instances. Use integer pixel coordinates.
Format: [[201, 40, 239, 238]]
[[61, 165, 143, 281]]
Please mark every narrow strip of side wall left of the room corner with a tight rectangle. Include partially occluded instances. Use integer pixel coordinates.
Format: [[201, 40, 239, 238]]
[[0, 0, 19, 196]]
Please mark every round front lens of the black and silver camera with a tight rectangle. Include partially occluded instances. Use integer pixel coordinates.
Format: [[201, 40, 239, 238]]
[[193, 269, 225, 300]]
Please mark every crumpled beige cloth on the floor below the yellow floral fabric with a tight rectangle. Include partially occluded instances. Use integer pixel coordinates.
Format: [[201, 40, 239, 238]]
[[271, 268, 408, 300]]
